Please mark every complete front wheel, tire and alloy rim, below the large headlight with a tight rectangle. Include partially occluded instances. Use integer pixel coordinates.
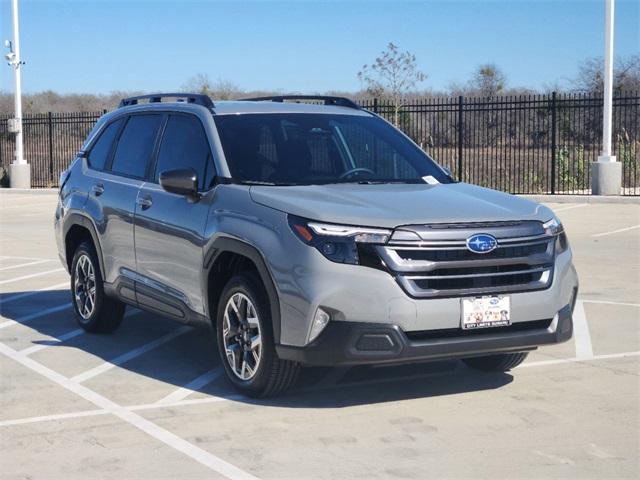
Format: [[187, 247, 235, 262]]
[[216, 272, 300, 397]]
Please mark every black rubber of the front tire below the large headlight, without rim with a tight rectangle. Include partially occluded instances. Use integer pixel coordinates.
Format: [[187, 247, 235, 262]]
[[216, 272, 300, 398]]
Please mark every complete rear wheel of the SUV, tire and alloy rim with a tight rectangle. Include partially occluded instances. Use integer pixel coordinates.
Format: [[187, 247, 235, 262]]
[[71, 242, 125, 333]]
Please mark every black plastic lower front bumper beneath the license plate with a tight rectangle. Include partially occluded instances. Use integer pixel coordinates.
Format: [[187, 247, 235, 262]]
[[276, 305, 573, 366]]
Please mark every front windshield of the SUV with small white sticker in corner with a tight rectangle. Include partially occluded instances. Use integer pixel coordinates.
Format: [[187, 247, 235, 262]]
[[214, 113, 452, 185]]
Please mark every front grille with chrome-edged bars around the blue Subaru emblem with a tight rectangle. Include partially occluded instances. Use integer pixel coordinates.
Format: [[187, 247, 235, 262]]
[[377, 222, 554, 298]]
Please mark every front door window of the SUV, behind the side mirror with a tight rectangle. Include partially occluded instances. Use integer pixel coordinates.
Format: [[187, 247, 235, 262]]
[[155, 115, 213, 190]]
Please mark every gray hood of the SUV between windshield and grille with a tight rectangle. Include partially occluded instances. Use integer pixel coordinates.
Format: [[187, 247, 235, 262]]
[[250, 183, 553, 228]]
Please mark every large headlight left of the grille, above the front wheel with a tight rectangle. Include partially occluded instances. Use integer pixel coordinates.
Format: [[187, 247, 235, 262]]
[[289, 216, 391, 265]]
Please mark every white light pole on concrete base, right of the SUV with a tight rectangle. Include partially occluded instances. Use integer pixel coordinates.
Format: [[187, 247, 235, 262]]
[[591, 0, 622, 195]]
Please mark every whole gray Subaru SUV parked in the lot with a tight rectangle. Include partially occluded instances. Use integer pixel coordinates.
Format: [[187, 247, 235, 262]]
[[55, 94, 578, 396]]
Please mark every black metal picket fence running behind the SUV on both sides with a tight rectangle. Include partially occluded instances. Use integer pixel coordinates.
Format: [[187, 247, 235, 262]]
[[0, 93, 640, 195]]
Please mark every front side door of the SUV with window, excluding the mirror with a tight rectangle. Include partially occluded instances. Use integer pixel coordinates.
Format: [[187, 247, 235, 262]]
[[135, 113, 214, 318]]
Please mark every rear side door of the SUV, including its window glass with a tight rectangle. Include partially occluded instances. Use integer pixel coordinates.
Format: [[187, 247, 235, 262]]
[[86, 115, 162, 300]]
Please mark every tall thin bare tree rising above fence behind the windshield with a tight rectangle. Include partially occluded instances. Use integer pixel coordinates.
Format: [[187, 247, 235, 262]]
[[358, 42, 427, 125]]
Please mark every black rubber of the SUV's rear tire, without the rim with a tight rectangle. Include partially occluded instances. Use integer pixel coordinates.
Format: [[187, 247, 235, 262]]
[[71, 241, 125, 333]]
